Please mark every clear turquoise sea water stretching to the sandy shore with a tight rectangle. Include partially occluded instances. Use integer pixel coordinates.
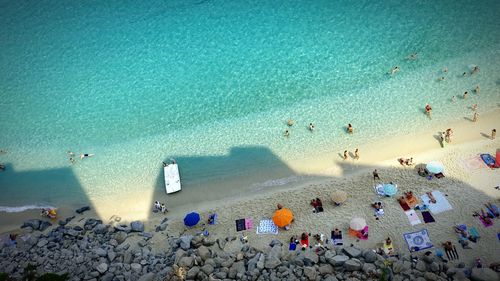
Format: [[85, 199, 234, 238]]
[[0, 0, 500, 210]]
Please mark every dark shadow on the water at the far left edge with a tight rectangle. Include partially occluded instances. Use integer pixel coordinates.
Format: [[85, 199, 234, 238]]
[[0, 165, 94, 213]]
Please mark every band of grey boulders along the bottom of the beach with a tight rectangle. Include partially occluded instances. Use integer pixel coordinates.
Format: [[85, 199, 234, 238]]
[[0, 215, 499, 281]]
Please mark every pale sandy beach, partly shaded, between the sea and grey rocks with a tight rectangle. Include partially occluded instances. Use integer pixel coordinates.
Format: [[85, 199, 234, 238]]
[[0, 110, 500, 263]]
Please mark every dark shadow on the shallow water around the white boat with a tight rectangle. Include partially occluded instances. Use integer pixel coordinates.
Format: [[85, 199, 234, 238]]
[[151, 146, 296, 215]]
